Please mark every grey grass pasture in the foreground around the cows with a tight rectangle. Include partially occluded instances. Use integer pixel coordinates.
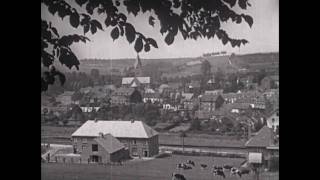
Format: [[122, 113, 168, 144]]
[[41, 155, 279, 180]]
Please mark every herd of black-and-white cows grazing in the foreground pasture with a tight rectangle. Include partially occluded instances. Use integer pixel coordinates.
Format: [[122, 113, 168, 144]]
[[172, 160, 251, 180]]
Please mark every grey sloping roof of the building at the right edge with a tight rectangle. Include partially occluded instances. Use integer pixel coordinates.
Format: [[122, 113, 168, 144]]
[[245, 126, 274, 147]]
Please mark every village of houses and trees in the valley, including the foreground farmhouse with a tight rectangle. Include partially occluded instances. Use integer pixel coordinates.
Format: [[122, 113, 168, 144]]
[[41, 52, 279, 179]]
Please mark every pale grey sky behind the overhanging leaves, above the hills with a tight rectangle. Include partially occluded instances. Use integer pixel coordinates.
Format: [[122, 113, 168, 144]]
[[41, 0, 279, 59]]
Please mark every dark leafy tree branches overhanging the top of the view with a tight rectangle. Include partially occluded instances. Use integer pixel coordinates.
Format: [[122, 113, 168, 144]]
[[41, 0, 253, 92]]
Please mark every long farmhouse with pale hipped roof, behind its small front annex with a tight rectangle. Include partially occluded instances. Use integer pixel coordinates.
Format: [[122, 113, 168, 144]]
[[72, 120, 159, 157]]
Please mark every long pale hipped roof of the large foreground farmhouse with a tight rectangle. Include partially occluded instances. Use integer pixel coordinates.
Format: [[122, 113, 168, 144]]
[[72, 120, 158, 138]]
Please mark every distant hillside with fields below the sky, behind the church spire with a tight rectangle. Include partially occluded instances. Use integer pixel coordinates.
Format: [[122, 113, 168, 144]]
[[52, 52, 279, 76]]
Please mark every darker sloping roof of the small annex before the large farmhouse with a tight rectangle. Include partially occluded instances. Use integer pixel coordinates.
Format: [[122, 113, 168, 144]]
[[94, 134, 124, 154]]
